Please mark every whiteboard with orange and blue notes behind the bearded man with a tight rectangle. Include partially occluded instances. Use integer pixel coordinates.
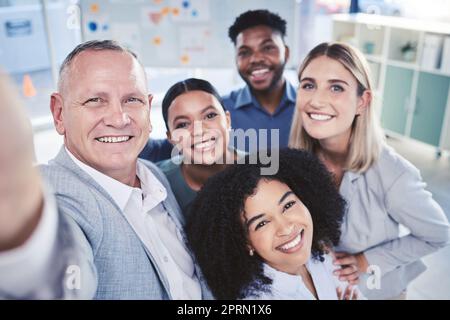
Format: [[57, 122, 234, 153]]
[[80, 0, 299, 68]]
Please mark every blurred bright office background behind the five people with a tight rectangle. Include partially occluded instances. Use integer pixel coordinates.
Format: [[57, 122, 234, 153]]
[[0, 0, 450, 299]]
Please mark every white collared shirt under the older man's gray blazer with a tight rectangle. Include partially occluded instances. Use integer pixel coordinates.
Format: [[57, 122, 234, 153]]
[[66, 148, 202, 300]]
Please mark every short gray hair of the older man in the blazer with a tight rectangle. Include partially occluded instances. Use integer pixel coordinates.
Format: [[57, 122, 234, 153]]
[[58, 40, 142, 91]]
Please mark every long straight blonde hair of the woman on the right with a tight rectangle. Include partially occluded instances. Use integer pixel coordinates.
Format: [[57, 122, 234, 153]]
[[289, 42, 384, 173]]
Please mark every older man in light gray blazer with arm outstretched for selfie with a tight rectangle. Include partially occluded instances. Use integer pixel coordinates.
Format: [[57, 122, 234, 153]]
[[0, 41, 211, 299]]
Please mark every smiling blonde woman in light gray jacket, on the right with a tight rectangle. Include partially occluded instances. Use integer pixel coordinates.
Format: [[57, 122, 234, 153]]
[[289, 43, 450, 299]]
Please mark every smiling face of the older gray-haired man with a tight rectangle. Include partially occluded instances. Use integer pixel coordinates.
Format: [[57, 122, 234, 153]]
[[52, 50, 151, 180]]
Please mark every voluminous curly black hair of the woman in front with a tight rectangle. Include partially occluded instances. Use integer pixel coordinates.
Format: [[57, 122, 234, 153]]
[[186, 149, 345, 299]]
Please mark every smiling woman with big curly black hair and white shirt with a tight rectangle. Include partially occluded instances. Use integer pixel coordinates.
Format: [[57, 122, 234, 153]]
[[187, 149, 361, 300]]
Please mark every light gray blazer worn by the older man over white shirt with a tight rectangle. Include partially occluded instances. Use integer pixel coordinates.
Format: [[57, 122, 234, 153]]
[[35, 147, 212, 299]]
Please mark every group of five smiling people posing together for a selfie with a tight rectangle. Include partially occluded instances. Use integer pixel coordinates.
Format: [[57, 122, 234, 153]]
[[0, 10, 450, 300]]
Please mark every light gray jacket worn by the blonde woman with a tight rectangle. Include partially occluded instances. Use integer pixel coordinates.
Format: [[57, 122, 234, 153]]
[[336, 146, 450, 299]]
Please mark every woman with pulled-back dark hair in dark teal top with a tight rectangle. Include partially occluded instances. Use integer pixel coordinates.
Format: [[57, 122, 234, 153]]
[[158, 78, 242, 214]]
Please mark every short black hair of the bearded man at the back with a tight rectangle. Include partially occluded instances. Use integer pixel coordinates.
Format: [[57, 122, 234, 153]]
[[228, 10, 286, 44]]
